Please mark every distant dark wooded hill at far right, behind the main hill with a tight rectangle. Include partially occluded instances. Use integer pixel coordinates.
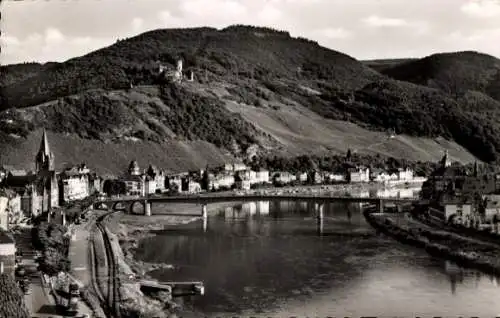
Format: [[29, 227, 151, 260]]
[[382, 51, 500, 100]]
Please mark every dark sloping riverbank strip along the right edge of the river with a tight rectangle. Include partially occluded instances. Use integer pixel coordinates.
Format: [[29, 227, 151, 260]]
[[363, 209, 500, 275]]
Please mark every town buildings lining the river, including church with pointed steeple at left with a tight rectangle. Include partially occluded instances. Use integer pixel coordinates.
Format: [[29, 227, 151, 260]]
[[0, 130, 500, 316]]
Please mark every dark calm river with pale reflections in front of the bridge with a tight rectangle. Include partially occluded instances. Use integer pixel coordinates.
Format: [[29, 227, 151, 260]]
[[136, 188, 500, 317]]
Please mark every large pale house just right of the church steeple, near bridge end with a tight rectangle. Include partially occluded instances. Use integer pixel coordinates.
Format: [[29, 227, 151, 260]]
[[59, 163, 90, 202]]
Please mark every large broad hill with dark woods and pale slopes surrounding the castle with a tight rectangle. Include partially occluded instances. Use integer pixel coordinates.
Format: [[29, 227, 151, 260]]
[[0, 25, 500, 174]]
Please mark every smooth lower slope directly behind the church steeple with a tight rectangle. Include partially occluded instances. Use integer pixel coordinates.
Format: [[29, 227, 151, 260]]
[[0, 130, 234, 176]]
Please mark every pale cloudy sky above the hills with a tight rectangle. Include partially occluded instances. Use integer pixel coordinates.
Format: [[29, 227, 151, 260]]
[[0, 0, 500, 65]]
